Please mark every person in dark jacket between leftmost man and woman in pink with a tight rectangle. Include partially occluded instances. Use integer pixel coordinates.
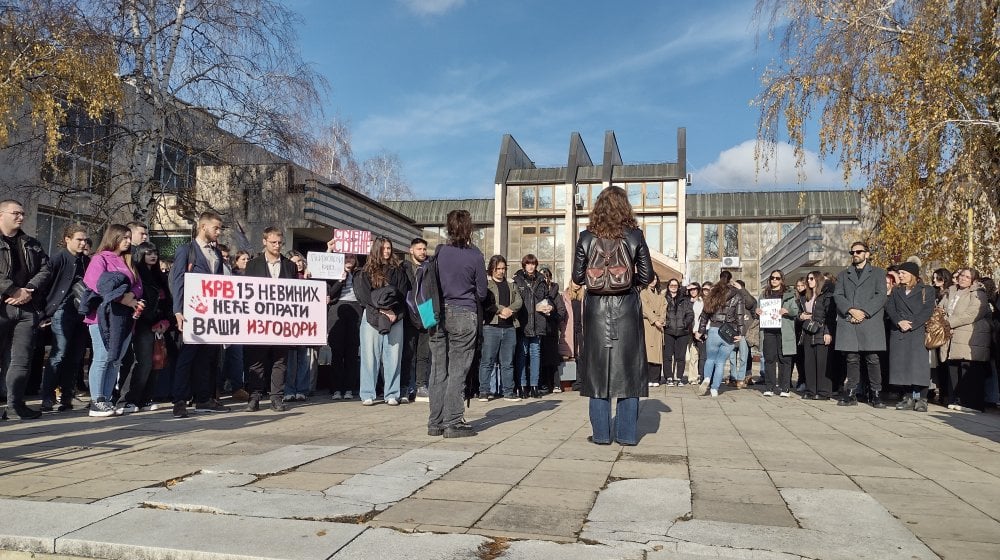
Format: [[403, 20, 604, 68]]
[[42, 224, 90, 412]]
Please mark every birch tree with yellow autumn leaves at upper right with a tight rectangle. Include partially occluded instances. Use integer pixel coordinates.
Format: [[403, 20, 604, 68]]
[[757, 0, 1000, 269]]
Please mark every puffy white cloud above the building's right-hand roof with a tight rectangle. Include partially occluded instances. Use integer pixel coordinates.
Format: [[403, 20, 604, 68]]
[[693, 140, 844, 191]]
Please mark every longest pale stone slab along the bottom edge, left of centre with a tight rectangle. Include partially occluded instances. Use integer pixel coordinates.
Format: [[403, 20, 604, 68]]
[[55, 509, 365, 560]]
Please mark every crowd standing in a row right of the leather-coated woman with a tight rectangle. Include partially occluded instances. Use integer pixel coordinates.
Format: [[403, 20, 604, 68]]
[[641, 242, 1000, 412]]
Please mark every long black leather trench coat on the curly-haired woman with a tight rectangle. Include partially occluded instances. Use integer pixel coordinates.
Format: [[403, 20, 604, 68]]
[[573, 229, 653, 399]]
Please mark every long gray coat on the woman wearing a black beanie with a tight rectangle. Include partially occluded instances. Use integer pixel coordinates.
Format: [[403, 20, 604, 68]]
[[885, 282, 936, 387]]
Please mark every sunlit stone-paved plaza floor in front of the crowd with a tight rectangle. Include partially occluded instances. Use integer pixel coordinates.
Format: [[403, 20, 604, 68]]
[[0, 387, 1000, 560]]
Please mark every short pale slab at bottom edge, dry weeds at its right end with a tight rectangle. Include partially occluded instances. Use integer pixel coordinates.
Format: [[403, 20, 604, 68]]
[[332, 529, 489, 560]]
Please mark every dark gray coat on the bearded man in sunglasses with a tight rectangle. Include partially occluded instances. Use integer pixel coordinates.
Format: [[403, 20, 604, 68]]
[[833, 264, 885, 352]]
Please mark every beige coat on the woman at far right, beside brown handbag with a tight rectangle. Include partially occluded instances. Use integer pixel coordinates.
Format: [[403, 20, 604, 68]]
[[939, 282, 992, 362]]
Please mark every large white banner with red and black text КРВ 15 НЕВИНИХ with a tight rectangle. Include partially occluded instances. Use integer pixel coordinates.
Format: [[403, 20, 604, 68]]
[[184, 272, 326, 346]]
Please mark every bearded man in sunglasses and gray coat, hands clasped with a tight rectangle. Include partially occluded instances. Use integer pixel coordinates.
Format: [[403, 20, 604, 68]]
[[833, 241, 886, 408]]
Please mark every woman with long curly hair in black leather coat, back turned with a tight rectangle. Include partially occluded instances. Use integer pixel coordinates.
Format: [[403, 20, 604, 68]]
[[573, 187, 653, 445]]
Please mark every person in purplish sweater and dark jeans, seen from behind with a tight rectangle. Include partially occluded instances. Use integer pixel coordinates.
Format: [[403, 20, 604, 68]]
[[427, 210, 486, 438]]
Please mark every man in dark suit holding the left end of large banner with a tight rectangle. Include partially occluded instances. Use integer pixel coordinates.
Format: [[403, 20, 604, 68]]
[[170, 212, 229, 418]]
